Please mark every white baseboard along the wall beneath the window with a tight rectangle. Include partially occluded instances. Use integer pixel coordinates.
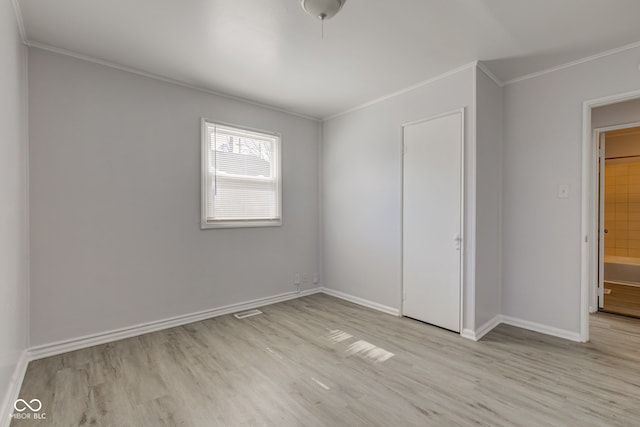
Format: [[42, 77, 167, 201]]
[[28, 288, 322, 360]]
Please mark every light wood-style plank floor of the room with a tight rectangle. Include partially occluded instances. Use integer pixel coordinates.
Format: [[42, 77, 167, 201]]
[[12, 294, 640, 427]]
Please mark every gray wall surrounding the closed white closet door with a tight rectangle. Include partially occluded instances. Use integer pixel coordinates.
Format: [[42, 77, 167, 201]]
[[322, 68, 475, 328]]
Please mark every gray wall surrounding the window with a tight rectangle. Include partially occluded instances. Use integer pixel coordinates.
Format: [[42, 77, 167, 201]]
[[29, 49, 319, 345]]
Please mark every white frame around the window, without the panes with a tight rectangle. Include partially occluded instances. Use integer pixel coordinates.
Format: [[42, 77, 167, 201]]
[[200, 118, 282, 229]]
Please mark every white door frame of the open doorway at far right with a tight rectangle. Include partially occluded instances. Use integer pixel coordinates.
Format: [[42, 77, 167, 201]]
[[580, 90, 640, 342]]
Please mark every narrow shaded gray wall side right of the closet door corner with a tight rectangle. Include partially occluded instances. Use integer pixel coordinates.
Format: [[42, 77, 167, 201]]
[[475, 69, 502, 328]]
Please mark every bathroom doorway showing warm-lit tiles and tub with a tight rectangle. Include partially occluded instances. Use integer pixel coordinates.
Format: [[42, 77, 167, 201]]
[[597, 124, 640, 318]]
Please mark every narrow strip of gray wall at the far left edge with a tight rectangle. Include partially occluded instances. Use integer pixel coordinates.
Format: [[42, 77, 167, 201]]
[[0, 0, 28, 412]]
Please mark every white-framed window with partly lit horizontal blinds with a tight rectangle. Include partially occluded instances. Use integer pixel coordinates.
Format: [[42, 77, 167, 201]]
[[201, 119, 282, 228]]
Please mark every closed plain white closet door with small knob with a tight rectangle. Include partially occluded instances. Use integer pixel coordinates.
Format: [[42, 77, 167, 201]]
[[402, 111, 463, 332]]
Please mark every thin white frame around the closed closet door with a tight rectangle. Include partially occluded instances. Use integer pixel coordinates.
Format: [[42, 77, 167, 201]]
[[400, 107, 467, 334]]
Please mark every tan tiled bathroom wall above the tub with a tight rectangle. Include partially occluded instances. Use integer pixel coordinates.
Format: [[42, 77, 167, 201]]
[[604, 157, 640, 258]]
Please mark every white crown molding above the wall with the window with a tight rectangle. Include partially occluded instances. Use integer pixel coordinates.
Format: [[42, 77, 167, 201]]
[[25, 41, 320, 122]]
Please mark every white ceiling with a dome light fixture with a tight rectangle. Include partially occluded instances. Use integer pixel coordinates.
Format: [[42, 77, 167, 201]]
[[19, 0, 640, 118]]
